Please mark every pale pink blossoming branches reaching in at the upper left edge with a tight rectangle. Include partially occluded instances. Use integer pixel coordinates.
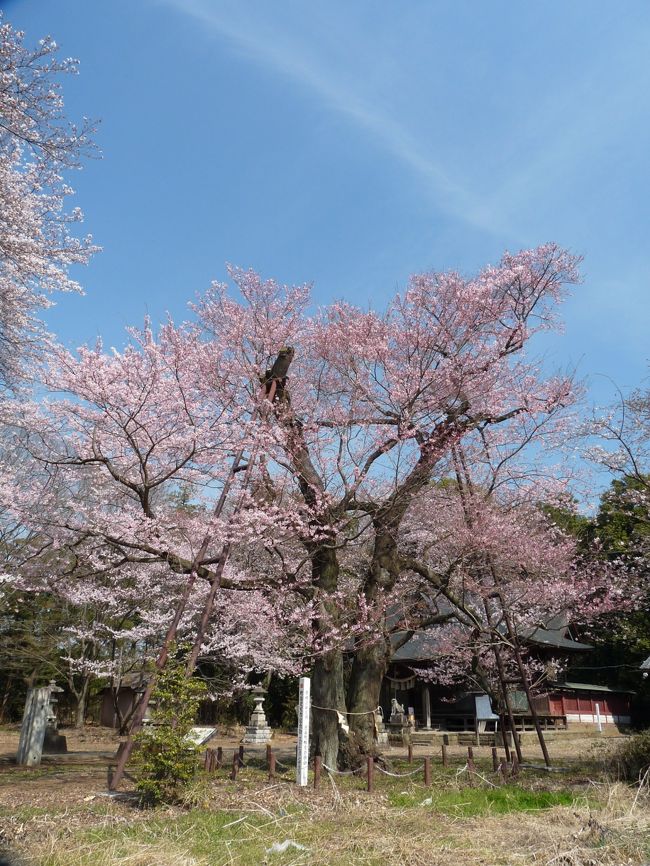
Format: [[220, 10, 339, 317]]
[[0, 16, 97, 387]]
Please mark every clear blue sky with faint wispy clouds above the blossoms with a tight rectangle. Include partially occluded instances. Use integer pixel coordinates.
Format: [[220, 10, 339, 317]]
[[0, 0, 650, 403]]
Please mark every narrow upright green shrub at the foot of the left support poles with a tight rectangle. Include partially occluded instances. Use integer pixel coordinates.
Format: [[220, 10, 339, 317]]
[[136, 657, 206, 805]]
